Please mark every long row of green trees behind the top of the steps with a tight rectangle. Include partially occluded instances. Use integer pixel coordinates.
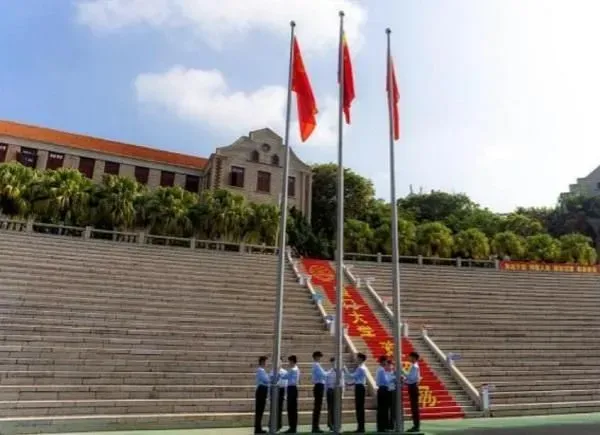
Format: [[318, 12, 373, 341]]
[[0, 163, 600, 264]]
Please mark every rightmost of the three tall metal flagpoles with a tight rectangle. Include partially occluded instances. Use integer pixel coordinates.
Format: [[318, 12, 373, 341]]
[[385, 28, 404, 433]]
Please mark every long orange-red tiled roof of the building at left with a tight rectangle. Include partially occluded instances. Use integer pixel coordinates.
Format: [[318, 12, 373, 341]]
[[0, 120, 208, 169]]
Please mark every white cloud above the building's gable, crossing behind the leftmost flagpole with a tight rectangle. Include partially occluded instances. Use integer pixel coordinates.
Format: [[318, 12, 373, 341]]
[[134, 66, 337, 146]]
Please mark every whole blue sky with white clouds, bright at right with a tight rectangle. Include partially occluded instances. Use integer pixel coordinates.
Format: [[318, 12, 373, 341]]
[[0, 0, 600, 212]]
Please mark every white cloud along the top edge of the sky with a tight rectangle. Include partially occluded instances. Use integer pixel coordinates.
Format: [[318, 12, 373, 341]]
[[76, 0, 367, 51]]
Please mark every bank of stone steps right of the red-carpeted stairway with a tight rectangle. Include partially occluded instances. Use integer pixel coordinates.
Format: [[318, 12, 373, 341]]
[[347, 262, 600, 416]]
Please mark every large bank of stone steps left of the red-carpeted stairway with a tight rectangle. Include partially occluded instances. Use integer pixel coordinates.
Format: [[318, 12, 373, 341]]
[[0, 231, 364, 434]]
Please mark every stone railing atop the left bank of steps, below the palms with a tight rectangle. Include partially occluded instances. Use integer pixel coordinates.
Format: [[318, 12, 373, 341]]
[[0, 218, 279, 255]]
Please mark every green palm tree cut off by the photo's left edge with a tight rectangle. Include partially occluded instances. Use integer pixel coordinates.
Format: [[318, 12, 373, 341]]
[[0, 163, 40, 217]]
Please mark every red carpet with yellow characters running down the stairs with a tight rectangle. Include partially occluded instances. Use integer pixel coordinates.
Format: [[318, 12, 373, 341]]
[[302, 258, 464, 419]]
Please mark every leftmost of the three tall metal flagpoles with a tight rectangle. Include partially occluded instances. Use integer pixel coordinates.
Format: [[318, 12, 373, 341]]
[[269, 21, 296, 434]]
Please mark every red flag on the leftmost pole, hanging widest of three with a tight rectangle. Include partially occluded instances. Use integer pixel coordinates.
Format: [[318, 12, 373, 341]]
[[292, 37, 318, 142]]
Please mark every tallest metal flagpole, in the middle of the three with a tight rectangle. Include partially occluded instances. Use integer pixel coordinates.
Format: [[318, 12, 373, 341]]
[[333, 11, 344, 434]]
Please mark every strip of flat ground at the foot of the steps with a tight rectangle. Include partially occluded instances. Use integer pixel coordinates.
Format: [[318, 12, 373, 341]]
[[51, 414, 600, 435]]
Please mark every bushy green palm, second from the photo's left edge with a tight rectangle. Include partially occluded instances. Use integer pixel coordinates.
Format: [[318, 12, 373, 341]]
[[28, 169, 93, 226]]
